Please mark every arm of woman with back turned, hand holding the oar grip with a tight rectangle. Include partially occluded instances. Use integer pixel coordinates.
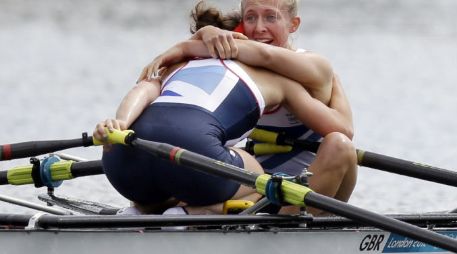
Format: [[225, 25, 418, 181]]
[[93, 79, 160, 140]]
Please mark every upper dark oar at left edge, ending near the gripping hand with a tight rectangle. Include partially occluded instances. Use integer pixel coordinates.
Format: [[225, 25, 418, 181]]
[[0, 133, 101, 161]]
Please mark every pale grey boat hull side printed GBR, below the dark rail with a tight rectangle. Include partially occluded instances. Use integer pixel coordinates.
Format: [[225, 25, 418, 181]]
[[0, 228, 457, 254]]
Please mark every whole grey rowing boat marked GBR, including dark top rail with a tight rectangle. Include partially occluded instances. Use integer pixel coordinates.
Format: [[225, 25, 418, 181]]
[[0, 207, 457, 254]]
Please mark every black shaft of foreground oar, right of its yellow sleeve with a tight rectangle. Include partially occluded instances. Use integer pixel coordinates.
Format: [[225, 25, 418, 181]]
[[304, 192, 457, 252]]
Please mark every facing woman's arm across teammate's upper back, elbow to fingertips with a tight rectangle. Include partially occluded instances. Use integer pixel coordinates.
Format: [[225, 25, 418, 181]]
[[139, 39, 333, 104]]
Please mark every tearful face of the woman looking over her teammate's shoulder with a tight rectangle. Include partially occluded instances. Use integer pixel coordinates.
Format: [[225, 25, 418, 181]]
[[242, 0, 298, 47]]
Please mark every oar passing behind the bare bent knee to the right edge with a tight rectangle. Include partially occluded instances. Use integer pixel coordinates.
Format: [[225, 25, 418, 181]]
[[247, 129, 457, 187]]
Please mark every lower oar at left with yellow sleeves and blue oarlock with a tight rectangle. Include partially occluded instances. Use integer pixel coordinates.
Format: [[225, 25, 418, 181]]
[[0, 160, 103, 187]]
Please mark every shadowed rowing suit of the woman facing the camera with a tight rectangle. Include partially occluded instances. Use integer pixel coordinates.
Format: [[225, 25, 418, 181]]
[[256, 49, 322, 175]]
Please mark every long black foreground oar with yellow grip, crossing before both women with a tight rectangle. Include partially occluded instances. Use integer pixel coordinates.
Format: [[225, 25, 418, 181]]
[[99, 131, 457, 252]]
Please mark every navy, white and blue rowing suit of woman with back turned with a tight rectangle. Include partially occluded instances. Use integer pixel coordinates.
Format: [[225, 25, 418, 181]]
[[103, 59, 265, 205]]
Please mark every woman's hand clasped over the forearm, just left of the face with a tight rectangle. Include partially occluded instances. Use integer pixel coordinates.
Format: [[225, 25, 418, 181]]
[[191, 26, 248, 59]]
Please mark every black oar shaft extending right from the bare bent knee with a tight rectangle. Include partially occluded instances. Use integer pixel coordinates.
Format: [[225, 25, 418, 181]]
[[357, 150, 457, 187]]
